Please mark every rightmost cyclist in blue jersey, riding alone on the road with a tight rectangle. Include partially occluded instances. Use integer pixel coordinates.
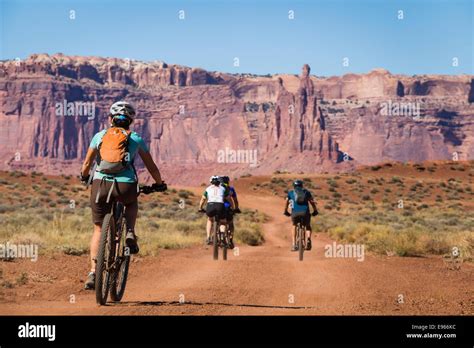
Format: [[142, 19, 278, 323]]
[[283, 180, 318, 251]]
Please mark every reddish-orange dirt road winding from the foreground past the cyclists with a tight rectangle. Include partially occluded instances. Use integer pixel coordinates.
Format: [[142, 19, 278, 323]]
[[0, 193, 474, 315]]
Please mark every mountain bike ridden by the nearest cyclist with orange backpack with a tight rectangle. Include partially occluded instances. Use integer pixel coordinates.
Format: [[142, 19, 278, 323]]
[[95, 183, 167, 305]]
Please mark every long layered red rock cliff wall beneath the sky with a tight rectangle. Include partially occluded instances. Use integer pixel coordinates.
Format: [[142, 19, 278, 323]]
[[0, 54, 474, 184]]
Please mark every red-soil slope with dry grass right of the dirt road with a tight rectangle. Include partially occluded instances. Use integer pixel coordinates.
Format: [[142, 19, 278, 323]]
[[239, 161, 474, 260]]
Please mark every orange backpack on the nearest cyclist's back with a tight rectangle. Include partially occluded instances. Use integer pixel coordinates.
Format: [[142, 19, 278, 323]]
[[97, 127, 132, 174]]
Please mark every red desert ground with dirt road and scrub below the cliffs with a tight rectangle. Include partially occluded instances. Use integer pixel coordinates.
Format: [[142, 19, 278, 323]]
[[0, 161, 474, 315]]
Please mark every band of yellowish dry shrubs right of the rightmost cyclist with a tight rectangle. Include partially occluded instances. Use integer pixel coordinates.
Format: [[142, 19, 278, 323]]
[[326, 205, 474, 260]]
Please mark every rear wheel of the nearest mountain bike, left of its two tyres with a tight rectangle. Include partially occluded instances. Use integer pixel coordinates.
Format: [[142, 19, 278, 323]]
[[95, 213, 115, 305]]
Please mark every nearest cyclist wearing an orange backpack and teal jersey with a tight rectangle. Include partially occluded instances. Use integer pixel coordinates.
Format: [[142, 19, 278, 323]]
[[81, 101, 163, 290]]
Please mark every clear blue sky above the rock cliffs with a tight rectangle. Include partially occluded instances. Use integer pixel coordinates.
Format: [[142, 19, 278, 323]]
[[0, 0, 474, 76]]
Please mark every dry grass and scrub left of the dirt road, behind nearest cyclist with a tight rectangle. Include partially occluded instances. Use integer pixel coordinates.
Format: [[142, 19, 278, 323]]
[[0, 172, 264, 255]]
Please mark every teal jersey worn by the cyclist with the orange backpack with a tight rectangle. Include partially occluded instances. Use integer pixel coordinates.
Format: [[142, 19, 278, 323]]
[[89, 129, 149, 183]]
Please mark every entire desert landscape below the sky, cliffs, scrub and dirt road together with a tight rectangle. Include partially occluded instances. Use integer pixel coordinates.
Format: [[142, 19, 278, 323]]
[[0, 54, 474, 315]]
